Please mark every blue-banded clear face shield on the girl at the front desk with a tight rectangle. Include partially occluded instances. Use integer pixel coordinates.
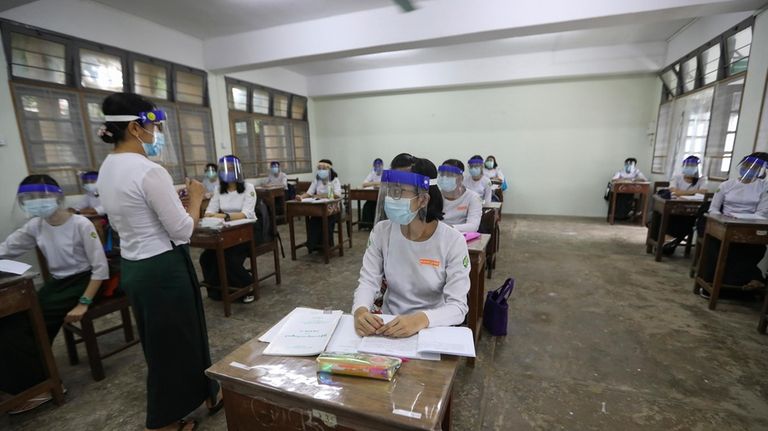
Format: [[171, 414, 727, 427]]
[[374, 170, 429, 233]]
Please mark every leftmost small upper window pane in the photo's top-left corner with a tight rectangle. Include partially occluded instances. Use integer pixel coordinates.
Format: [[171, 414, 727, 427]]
[[11, 33, 67, 84]]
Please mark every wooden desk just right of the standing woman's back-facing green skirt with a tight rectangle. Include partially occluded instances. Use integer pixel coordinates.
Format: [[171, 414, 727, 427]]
[[189, 223, 259, 317]]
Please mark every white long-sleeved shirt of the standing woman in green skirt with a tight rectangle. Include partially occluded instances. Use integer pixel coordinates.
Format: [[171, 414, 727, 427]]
[[97, 153, 195, 260]]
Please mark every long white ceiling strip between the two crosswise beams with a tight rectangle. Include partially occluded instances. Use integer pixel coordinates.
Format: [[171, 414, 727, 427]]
[[283, 19, 691, 76]]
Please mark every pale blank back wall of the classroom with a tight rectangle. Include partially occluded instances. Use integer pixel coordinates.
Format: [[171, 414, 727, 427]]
[[311, 76, 660, 216]]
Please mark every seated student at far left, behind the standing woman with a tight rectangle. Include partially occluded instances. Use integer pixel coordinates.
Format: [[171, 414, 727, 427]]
[[0, 175, 109, 414]]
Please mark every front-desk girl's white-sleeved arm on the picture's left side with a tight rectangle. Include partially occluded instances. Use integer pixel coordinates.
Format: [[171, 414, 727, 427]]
[[352, 223, 384, 336]]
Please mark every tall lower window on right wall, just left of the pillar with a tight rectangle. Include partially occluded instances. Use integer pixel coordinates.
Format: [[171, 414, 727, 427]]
[[705, 77, 744, 180]]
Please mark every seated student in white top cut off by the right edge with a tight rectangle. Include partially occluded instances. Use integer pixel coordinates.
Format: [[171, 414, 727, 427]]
[[699, 155, 768, 298]]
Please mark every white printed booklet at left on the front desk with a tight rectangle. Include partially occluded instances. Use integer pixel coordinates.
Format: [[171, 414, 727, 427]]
[[264, 308, 342, 356]]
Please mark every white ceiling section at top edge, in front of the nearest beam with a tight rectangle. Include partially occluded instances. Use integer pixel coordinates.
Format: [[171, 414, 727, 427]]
[[94, 0, 414, 39]]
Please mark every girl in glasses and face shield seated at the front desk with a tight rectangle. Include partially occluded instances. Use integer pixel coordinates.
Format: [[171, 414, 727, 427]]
[[352, 156, 470, 337]]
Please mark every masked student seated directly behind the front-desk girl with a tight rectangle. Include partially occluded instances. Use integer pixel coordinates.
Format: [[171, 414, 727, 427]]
[[437, 159, 483, 232]]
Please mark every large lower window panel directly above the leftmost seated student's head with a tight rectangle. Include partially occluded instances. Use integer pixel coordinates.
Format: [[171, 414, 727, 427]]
[[13, 85, 92, 193]]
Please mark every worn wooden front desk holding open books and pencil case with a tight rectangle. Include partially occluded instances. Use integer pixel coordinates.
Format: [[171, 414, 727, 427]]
[[206, 339, 459, 431]]
